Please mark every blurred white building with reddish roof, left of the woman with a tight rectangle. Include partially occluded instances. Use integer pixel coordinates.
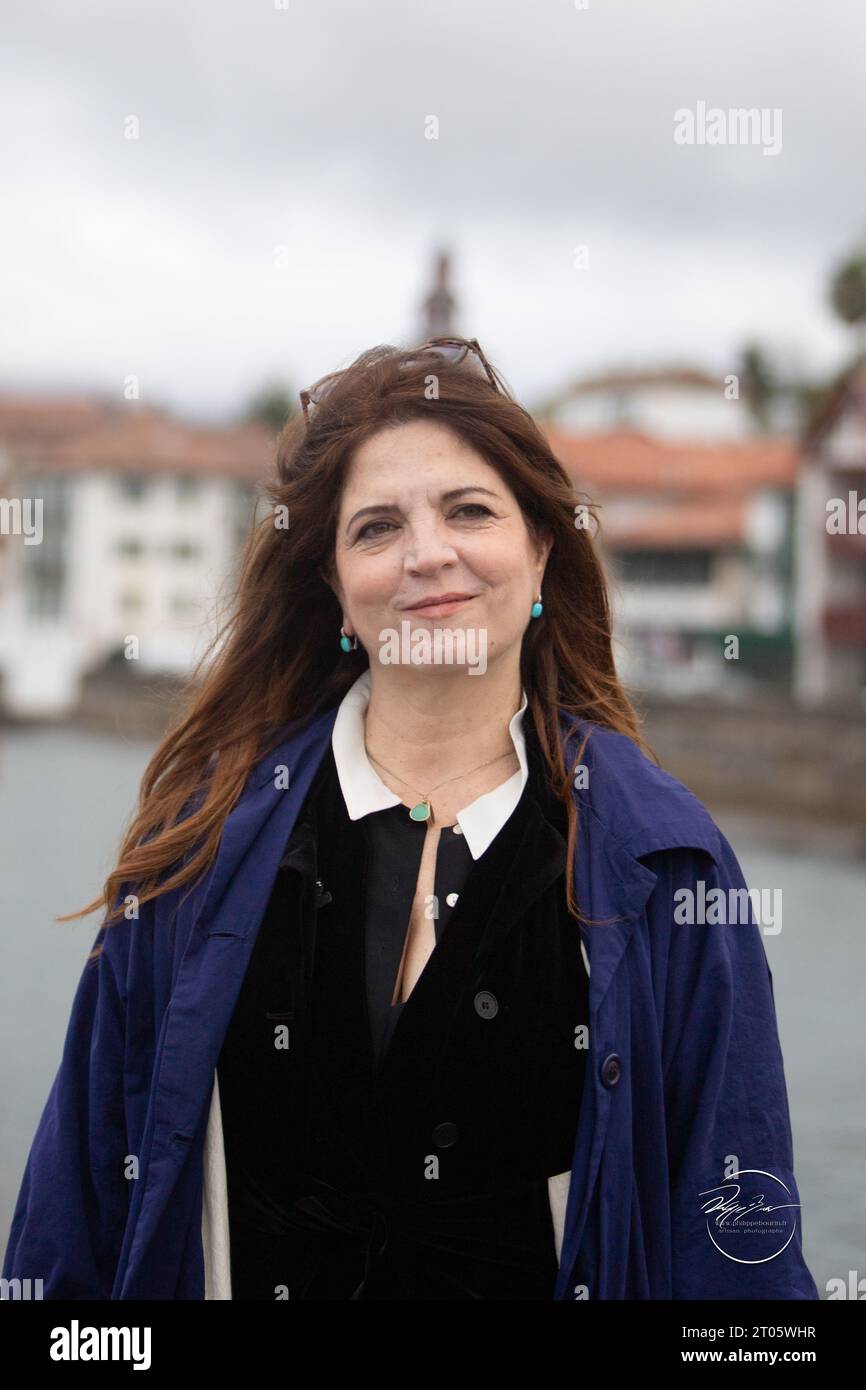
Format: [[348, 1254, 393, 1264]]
[[0, 399, 274, 717]]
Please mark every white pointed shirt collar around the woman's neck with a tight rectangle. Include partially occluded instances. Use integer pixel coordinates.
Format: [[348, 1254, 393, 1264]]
[[331, 669, 530, 859]]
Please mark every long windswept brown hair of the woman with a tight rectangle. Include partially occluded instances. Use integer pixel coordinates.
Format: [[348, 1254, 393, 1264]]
[[56, 346, 655, 954]]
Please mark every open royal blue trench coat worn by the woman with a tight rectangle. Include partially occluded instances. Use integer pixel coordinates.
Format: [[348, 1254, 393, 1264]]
[[3, 709, 819, 1300]]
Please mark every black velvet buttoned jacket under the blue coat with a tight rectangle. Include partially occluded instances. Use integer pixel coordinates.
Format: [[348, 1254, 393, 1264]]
[[218, 712, 588, 1300]]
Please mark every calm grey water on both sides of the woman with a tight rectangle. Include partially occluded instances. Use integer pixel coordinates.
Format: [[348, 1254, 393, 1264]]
[[0, 728, 866, 1293]]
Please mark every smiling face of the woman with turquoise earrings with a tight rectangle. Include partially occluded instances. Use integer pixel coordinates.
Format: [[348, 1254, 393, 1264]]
[[332, 420, 550, 678]]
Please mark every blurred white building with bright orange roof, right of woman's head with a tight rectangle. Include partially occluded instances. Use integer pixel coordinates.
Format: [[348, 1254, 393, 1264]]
[[546, 428, 798, 696]]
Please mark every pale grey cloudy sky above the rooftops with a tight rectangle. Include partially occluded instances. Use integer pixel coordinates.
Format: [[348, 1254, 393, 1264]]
[[0, 0, 866, 418]]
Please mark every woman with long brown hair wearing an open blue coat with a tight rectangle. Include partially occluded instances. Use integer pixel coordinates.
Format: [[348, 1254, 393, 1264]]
[[4, 339, 817, 1300]]
